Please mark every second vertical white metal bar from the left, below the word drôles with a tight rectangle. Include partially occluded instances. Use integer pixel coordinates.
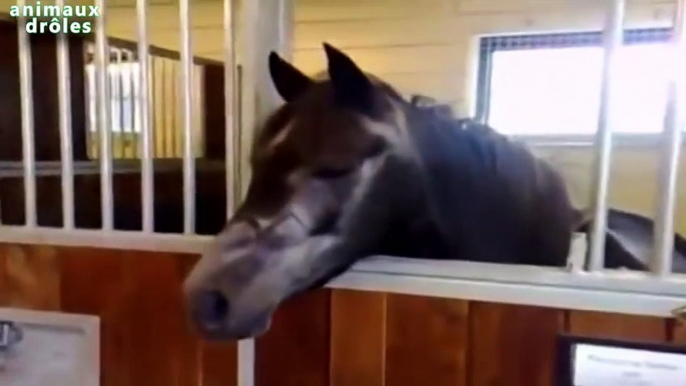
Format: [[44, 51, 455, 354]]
[[56, 0, 75, 230]]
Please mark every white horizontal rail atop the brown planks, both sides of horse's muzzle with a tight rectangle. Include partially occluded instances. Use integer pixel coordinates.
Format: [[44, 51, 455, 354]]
[[0, 226, 686, 317]]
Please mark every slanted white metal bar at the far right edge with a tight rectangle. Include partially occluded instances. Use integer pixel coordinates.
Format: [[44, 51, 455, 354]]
[[650, 0, 686, 276]]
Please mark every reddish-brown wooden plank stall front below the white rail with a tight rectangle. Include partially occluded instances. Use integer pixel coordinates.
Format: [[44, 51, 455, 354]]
[[0, 245, 686, 386]]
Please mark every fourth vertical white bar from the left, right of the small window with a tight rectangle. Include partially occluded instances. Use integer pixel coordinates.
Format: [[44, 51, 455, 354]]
[[136, 0, 155, 233]]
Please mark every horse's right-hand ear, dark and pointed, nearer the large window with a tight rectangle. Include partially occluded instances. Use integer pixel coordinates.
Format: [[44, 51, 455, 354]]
[[324, 43, 374, 112]]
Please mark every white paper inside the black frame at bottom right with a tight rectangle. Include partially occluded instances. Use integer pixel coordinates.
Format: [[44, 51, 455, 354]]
[[573, 344, 686, 386]]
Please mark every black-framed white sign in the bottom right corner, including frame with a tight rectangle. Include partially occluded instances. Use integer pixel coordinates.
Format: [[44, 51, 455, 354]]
[[555, 335, 686, 386]]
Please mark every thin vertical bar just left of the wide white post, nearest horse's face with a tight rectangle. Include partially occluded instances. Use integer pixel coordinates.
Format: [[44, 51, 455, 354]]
[[224, 0, 236, 219]]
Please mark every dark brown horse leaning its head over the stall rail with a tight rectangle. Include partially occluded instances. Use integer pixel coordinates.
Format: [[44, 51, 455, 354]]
[[183, 43, 686, 340]]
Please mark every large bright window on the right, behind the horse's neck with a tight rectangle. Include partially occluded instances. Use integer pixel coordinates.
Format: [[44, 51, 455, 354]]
[[477, 29, 672, 136]]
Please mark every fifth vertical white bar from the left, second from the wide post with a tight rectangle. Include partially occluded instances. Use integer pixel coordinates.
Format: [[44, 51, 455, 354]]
[[180, 0, 195, 234]]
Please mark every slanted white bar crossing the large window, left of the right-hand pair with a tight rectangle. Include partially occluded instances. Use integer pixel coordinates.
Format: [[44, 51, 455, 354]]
[[587, 0, 625, 271]]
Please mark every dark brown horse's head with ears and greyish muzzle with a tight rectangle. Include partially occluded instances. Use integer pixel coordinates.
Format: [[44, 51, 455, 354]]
[[184, 44, 420, 339]]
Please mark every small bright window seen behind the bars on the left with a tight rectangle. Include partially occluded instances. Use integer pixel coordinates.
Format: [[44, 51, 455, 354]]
[[86, 62, 140, 133]]
